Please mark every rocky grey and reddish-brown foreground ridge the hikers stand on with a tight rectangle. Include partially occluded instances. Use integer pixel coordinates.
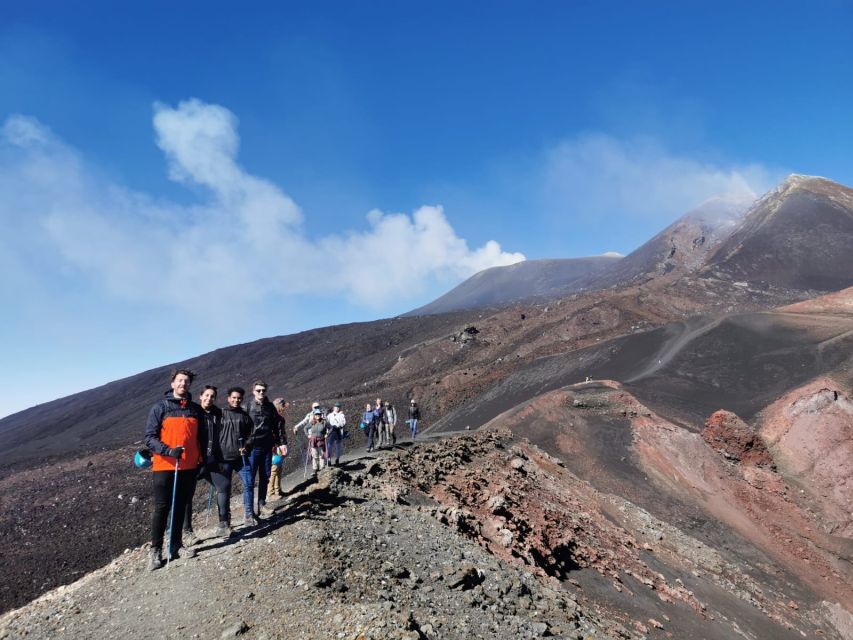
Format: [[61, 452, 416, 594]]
[[5, 430, 848, 640]]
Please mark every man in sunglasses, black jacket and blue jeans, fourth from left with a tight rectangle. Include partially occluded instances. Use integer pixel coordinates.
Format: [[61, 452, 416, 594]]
[[240, 380, 287, 525]]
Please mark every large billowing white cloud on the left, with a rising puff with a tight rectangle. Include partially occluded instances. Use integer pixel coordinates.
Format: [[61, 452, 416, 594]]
[[0, 100, 524, 319]]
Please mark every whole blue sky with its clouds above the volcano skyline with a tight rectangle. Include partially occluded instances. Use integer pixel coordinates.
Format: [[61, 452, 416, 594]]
[[0, 0, 853, 415]]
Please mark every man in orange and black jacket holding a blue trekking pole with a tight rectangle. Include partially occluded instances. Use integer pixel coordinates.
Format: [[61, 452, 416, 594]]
[[145, 369, 207, 570]]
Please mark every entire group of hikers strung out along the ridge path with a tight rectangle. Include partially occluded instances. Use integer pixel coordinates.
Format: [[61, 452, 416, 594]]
[[141, 369, 421, 570]]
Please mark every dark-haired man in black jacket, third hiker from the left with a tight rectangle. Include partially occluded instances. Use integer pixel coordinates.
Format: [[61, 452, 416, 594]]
[[209, 387, 255, 537]]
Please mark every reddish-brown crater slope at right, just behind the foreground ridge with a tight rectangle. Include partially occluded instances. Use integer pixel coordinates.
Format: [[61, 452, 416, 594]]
[[482, 382, 853, 637]]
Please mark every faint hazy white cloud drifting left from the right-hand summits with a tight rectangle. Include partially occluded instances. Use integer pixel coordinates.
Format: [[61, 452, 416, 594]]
[[538, 133, 782, 223]]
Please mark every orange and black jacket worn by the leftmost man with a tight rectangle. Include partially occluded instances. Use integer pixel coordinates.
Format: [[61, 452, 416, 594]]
[[145, 390, 207, 471]]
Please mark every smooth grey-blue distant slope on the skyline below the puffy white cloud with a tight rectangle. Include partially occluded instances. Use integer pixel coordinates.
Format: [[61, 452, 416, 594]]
[[406, 255, 621, 316]]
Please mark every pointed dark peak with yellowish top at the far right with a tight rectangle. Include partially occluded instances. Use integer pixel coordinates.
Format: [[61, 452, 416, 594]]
[[704, 175, 853, 291]]
